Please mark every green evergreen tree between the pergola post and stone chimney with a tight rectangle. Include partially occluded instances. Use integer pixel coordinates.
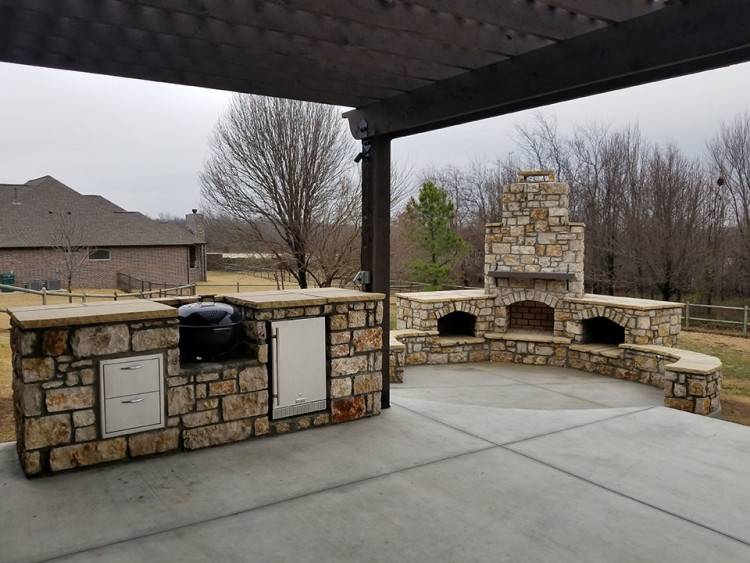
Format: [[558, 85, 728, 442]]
[[406, 182, 466, 289]]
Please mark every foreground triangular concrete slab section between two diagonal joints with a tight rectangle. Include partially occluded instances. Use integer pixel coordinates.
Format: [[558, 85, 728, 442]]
[[54, 448, 750, 563]]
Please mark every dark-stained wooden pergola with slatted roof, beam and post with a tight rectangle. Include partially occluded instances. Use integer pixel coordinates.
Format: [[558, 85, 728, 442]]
[[0, 0, 750, 407]]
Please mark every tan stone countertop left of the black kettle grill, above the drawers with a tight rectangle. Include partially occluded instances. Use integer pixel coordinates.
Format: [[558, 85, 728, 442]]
[[8, 299, 177, 329]]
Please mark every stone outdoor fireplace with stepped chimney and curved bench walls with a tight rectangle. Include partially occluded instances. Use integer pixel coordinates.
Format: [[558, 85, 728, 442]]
[[391, 171, 721, 414]]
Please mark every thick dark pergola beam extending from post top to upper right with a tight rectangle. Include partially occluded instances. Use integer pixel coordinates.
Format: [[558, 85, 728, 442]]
[[345, 0, 750, 138]]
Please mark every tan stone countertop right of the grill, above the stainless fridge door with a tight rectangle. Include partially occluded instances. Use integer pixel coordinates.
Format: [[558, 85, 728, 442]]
[[216, 287, 385, 309]]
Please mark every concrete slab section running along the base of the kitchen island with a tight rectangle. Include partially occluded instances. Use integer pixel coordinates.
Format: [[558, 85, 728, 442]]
[[0, 409, 490, 561]]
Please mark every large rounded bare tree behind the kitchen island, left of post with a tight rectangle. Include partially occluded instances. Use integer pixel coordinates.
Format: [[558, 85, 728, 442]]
[[201, 94, 356, 287]]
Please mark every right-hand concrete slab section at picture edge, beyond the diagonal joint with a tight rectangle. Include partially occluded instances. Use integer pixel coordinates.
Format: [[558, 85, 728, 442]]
[[511, 407, 750, 548]]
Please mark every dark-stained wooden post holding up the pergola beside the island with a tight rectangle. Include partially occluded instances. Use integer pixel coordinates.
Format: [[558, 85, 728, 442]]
[[362, 137, 391, 408]]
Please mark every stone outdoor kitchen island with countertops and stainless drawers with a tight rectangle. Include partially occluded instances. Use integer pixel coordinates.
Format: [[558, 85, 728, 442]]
[[10, 288, 384, 475]]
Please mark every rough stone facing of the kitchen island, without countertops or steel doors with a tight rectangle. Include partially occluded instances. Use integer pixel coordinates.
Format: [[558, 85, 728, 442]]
[[12, 301, 383, 475]]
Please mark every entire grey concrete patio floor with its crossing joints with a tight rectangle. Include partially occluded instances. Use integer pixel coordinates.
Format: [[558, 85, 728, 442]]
[[0, 366, 750, 563]]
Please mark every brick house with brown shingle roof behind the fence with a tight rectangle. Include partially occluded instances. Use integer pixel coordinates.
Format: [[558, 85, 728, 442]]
[[0, 176, 206, 288]]
